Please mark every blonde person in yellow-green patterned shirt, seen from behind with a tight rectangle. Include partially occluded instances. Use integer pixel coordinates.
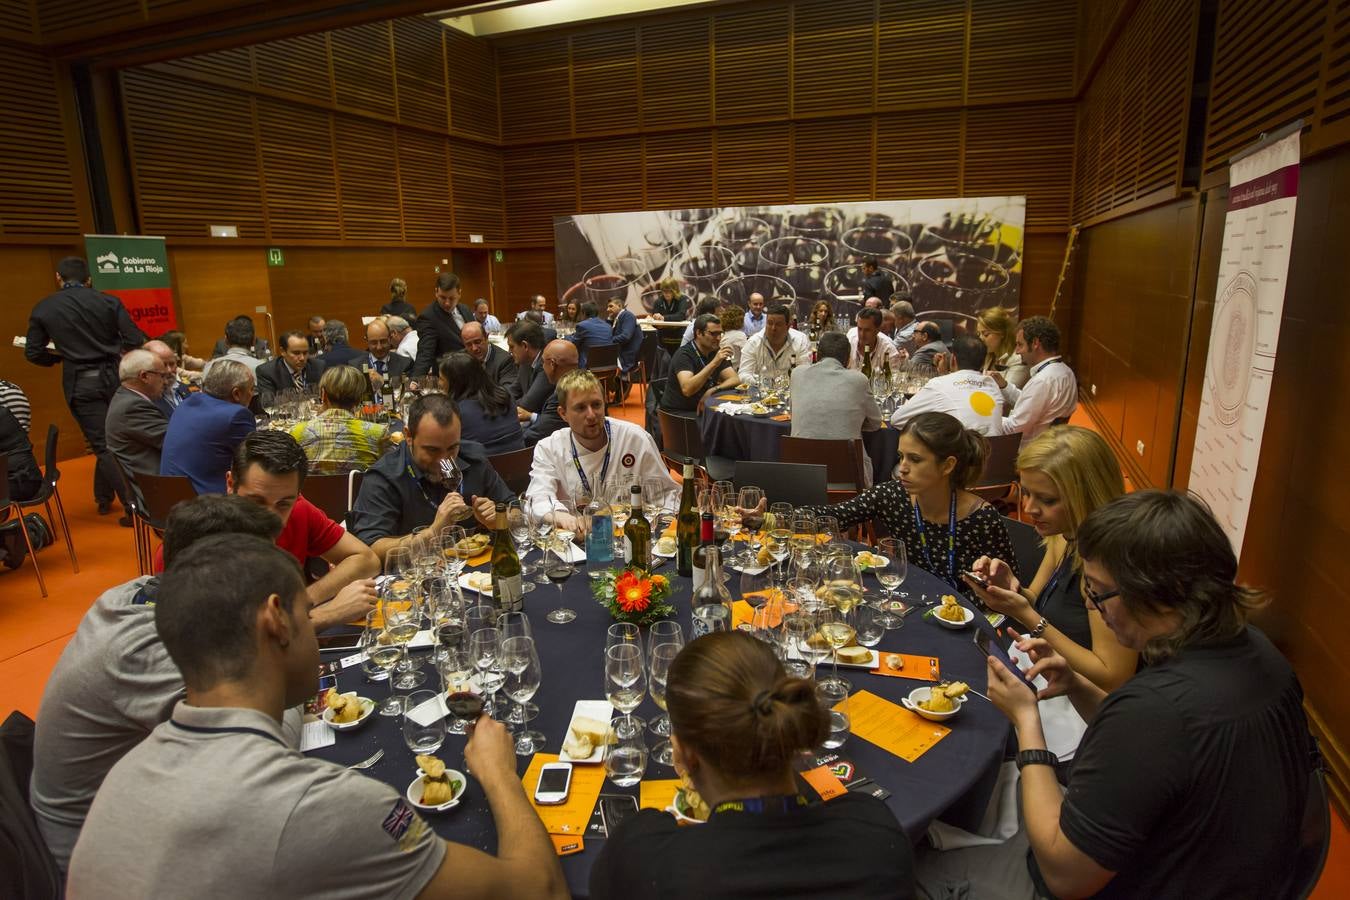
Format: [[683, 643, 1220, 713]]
[[290, 366, 393, 475]]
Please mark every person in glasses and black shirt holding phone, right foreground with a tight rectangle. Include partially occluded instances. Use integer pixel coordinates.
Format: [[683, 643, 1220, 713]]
[[988, 491, 1326, 900]]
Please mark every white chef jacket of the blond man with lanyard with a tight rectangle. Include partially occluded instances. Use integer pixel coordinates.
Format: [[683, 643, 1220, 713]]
[[525, 418, 679, 513]]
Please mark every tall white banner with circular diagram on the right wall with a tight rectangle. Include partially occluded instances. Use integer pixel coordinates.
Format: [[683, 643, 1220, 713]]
[[1189, 128, 1299, 557]]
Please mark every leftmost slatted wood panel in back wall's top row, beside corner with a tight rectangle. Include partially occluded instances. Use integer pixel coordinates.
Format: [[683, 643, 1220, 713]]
[[497, 36, 572, 142]]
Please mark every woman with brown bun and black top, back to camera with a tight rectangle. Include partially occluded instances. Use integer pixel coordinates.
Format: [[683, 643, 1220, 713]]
[[590, 631, 914, 900]]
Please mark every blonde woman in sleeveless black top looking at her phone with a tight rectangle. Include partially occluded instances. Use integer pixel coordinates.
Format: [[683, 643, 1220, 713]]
[[968, 425, 1139, 691]]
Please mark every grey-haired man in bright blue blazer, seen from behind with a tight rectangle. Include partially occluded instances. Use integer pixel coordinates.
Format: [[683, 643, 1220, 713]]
[[159, 359, 254, 494]]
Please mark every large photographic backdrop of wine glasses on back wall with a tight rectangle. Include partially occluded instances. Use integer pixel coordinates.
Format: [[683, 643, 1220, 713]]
[[554, 197, 1026, 327]]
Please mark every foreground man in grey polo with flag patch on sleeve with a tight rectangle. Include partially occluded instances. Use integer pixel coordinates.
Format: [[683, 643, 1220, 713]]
[[68, 534, 567, 899]]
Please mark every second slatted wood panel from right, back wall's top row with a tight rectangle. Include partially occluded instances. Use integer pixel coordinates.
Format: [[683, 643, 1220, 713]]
[[876, 0, 969, 109]]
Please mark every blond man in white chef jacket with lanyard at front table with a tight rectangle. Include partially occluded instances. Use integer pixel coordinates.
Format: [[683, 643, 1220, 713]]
[[525, 368, 678, 530]]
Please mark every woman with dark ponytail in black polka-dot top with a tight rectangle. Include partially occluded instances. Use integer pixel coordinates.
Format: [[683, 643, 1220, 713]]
[[811, 413, 1013, 594]]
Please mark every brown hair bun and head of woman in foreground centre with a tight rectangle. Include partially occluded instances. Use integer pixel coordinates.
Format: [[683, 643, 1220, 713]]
[[666, 631, 829, 781]]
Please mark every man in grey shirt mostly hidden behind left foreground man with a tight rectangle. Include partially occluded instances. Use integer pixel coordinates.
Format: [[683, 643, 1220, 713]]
[[30, 494, 291, 872]]
